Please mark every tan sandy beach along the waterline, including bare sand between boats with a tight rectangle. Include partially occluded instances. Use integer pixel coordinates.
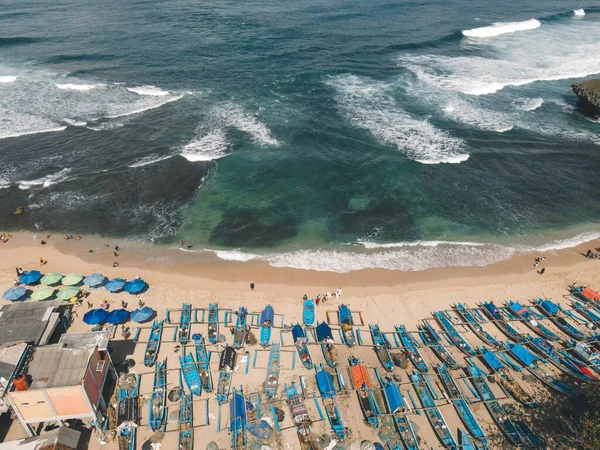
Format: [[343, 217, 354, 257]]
[[0, 232, 600, 449]]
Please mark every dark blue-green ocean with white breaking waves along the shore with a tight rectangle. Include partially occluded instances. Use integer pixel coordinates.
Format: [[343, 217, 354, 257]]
[[0, 0, 600, 272]]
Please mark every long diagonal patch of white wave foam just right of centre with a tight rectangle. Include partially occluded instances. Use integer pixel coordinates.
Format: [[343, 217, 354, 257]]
[[327, 75, 469, 164]]
